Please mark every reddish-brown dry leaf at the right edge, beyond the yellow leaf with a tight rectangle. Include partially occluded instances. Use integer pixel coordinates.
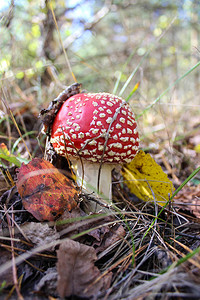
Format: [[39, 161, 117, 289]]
[[174, 184, 200, 218]]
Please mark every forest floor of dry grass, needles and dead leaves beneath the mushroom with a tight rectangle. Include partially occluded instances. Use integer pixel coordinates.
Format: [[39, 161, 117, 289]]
[[0, 87, 200, 300]]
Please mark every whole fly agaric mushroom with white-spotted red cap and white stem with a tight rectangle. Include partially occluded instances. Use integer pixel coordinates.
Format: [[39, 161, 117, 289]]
[[50, 93, 139, 211]]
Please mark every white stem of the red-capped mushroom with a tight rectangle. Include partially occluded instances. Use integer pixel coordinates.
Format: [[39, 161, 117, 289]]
[[70, 158, 116, 212]]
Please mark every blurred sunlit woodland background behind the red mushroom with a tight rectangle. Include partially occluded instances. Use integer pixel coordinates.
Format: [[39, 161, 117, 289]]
[[0, 0, 200, 179]]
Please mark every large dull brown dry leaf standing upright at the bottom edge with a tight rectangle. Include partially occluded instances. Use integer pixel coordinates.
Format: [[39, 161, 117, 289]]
[[57, 239, 111, 298]]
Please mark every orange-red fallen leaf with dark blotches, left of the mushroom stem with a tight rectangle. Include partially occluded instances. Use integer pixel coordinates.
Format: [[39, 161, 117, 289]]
[[16, 158, 78, 221]]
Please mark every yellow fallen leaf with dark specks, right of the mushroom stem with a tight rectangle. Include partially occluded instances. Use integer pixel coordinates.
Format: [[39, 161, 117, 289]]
[[122, 151, 174, 206]]
